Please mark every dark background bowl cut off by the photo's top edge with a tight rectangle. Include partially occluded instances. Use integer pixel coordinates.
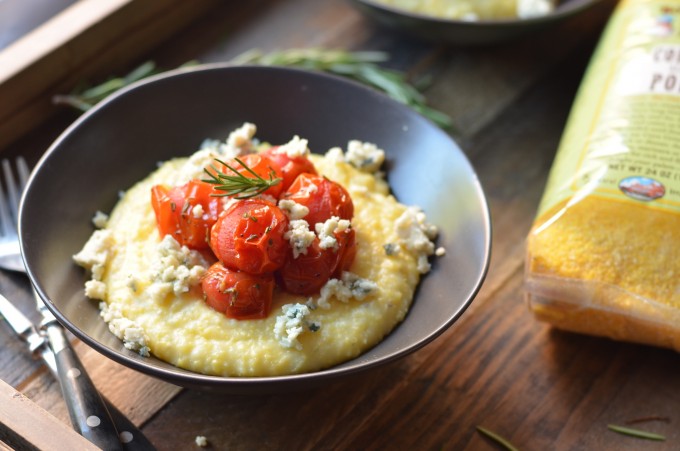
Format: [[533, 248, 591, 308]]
[[351, 0, 599, 45]]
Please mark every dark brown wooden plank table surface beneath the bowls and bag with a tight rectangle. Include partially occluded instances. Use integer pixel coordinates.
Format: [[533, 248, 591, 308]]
[[0, 0, 680, 450]]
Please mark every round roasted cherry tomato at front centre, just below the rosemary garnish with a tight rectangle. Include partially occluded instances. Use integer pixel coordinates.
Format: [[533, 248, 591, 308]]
[[210, 199, 290, 274]]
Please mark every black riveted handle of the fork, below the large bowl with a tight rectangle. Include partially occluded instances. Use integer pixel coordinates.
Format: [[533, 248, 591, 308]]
[[45, 321, 122, 451]]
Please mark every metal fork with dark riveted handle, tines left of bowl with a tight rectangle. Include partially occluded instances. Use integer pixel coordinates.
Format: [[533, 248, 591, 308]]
[[0, 157, 153, 450]]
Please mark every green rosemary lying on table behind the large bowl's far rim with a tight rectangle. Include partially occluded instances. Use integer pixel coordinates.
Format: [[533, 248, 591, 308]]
[[53, 49, 452, 128]]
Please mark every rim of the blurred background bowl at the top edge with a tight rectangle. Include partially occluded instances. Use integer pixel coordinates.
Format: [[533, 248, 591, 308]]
[[353, 0, 601, 28]]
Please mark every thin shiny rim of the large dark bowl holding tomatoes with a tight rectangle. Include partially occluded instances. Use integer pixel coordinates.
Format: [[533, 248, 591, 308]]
[[19, 63, 492, 394]]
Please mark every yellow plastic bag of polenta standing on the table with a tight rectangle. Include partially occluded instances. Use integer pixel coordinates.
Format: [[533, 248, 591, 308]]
[[525, 0, 680, 351]]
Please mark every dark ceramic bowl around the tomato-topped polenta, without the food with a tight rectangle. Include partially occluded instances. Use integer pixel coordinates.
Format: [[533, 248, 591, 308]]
[[19, 65, 491, 393]]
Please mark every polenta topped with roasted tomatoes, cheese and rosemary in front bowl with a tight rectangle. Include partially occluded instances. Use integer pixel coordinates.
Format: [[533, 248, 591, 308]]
[[74, 124, 443, 376]]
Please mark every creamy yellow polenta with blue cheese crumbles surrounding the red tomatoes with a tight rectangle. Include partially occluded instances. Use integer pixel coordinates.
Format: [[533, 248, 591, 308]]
[[74, 124, 443, 376]]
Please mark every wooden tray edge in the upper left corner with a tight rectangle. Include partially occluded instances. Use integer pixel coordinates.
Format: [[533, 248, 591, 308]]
[[0, 0, 220, 150]]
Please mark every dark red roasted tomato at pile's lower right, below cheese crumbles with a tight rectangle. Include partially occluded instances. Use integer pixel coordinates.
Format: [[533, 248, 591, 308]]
[[277, 229, 356, 296]]
